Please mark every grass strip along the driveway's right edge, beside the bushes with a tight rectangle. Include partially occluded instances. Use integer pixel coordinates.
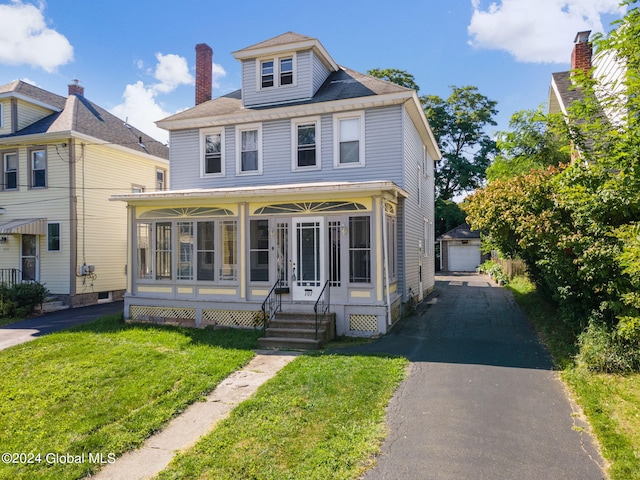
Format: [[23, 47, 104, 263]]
[[509, 278, 640, 480]]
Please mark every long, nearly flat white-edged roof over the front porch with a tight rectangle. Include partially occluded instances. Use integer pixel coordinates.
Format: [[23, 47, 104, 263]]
[[111, 181, 409, 204]]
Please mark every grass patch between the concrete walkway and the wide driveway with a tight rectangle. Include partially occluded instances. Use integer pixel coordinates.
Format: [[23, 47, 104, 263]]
[[158, 355, 408, 480]]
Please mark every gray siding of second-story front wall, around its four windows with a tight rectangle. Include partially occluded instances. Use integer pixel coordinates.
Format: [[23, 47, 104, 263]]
[[165, 106, 404, 190]]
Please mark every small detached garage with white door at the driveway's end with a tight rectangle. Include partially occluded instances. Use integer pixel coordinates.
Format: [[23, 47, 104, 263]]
[[437, 223, 482, 272]]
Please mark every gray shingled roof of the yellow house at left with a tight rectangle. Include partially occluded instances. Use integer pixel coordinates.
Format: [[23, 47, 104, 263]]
[[0, 81, 169, 159]]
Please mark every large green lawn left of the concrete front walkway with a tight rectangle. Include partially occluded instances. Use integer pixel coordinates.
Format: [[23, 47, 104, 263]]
[[0, 316, 259, 480]]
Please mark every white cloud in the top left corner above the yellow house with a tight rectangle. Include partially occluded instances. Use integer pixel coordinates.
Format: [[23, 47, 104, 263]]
[[0, 0, 73, 73]]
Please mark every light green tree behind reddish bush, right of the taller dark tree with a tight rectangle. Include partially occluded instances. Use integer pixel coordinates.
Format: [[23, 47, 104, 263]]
[[486, 107, 571, 182]]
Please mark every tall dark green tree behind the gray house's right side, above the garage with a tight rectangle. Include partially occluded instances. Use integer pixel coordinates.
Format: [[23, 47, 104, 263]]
[[420, 86, 498, 200]]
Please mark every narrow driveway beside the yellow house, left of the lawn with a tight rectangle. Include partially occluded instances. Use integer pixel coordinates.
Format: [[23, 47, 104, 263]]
[[0, 300, 124, 350]]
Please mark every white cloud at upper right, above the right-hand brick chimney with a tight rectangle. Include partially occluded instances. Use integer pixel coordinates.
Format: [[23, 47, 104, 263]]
[[468, 0, 622, 63]]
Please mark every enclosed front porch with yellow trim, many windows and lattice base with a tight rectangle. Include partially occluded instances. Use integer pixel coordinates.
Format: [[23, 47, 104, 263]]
[[115, 182, 403, 336]]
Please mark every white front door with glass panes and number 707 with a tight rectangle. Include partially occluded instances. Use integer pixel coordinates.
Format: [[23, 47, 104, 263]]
[[291, 217, 326, 302]]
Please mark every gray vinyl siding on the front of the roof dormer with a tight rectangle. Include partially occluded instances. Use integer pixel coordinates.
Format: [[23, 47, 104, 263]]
[[242, 50, 313, 107]]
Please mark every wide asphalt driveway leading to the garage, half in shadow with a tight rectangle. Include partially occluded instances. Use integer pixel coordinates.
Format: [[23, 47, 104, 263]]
[[340, 274, 605, 480]]
